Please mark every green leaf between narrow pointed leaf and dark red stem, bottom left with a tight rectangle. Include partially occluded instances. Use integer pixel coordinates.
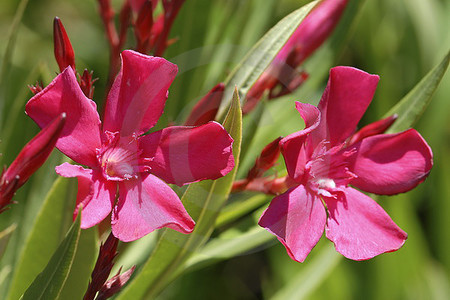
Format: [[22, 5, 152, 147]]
[[59, 227, 99, 299]]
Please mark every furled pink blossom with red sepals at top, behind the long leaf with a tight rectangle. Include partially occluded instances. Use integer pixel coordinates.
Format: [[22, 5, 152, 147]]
[[242, 0, 348, 113]]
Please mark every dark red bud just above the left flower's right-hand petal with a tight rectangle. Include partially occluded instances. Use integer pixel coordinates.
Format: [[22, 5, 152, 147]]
[[185, 83, 225, 126]]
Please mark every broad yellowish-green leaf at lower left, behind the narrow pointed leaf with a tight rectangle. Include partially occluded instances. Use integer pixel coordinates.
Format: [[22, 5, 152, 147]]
[[7, 177, 70, 300]]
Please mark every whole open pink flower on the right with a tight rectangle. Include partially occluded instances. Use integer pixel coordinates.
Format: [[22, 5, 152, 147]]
[[259, 67, 433, 262]]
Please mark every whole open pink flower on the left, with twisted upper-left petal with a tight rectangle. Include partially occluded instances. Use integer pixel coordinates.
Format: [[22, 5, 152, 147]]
[[26, 50, 234, 241]]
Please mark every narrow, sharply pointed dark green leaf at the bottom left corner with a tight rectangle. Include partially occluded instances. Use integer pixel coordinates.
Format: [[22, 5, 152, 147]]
[[21, 212, 81, 300]]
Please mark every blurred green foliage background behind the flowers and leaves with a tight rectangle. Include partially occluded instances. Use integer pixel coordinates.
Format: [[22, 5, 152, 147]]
[[0, 0, 450, 299]]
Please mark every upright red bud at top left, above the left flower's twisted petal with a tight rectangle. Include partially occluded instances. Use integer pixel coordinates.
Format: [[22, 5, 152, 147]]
[[53, 17, 75, 72]]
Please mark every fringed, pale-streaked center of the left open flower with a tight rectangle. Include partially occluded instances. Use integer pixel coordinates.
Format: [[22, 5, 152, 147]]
[[97, 132, 151, 181]]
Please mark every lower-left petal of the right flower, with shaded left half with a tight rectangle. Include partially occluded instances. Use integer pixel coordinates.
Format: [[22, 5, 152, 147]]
[[258, 185, 326, 262]]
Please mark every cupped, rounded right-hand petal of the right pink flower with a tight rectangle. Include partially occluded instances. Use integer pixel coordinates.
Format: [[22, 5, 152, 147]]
[[350, 129, 433, 195]]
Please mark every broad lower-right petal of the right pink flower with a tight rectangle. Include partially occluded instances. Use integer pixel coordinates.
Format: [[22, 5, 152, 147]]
[[324, 188, 407, 260]]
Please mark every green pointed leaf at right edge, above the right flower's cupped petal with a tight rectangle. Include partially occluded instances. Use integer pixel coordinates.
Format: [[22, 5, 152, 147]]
[[385, 51, 450, 133]]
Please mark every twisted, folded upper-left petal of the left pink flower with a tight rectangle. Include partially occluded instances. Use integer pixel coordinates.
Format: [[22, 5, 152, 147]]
[[25, 67, 101, 167]]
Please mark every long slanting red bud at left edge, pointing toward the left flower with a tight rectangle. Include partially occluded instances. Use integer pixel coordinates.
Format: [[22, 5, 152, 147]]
[[0, 113, 66, 212]]
